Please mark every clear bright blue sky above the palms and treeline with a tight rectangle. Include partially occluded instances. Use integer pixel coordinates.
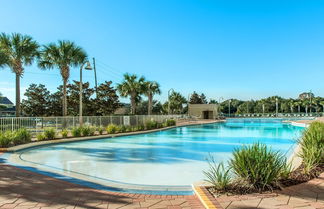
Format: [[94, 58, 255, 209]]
[[0, 0, 324, 103]]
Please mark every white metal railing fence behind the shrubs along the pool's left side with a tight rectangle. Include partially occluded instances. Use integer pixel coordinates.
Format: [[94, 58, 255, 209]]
[[0, 115, 187, 132]]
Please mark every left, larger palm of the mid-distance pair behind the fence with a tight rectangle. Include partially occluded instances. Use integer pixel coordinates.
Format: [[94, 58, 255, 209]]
[[117, 73, 145, 114]]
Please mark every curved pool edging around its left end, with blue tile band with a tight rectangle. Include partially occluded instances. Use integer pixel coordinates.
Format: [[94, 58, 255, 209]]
[[0, 120, 223, 195]]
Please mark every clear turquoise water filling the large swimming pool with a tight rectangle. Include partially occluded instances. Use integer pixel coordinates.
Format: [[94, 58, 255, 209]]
[[12, 120, 303, 185]]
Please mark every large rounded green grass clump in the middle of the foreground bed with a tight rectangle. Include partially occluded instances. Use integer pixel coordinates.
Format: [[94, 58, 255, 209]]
[[230, 143, 286, 191]]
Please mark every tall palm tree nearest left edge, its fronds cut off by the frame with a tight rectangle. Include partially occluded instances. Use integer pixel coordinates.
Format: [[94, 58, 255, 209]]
[[0, 33, 39, 117]]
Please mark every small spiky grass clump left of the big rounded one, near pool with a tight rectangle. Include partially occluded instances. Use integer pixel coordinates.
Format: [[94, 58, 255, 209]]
[[204, 156, 231, 191]]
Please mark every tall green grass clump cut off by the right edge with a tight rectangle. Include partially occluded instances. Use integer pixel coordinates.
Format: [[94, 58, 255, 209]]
[[299, 121, 324, 174]]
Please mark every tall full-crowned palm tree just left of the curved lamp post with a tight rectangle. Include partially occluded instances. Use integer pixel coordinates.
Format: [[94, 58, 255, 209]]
[[38, 41, 87, 116]]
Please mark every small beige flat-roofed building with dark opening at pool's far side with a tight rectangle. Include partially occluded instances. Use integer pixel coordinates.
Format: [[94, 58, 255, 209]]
[[188, 104, 218, 119]]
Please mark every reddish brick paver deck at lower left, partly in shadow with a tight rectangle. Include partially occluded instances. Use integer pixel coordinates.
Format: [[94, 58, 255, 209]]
[[0, 158, 204, 209]]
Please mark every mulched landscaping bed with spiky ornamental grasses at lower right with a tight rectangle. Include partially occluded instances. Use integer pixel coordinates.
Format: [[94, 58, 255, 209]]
[[204, 122, 324, 197]]
